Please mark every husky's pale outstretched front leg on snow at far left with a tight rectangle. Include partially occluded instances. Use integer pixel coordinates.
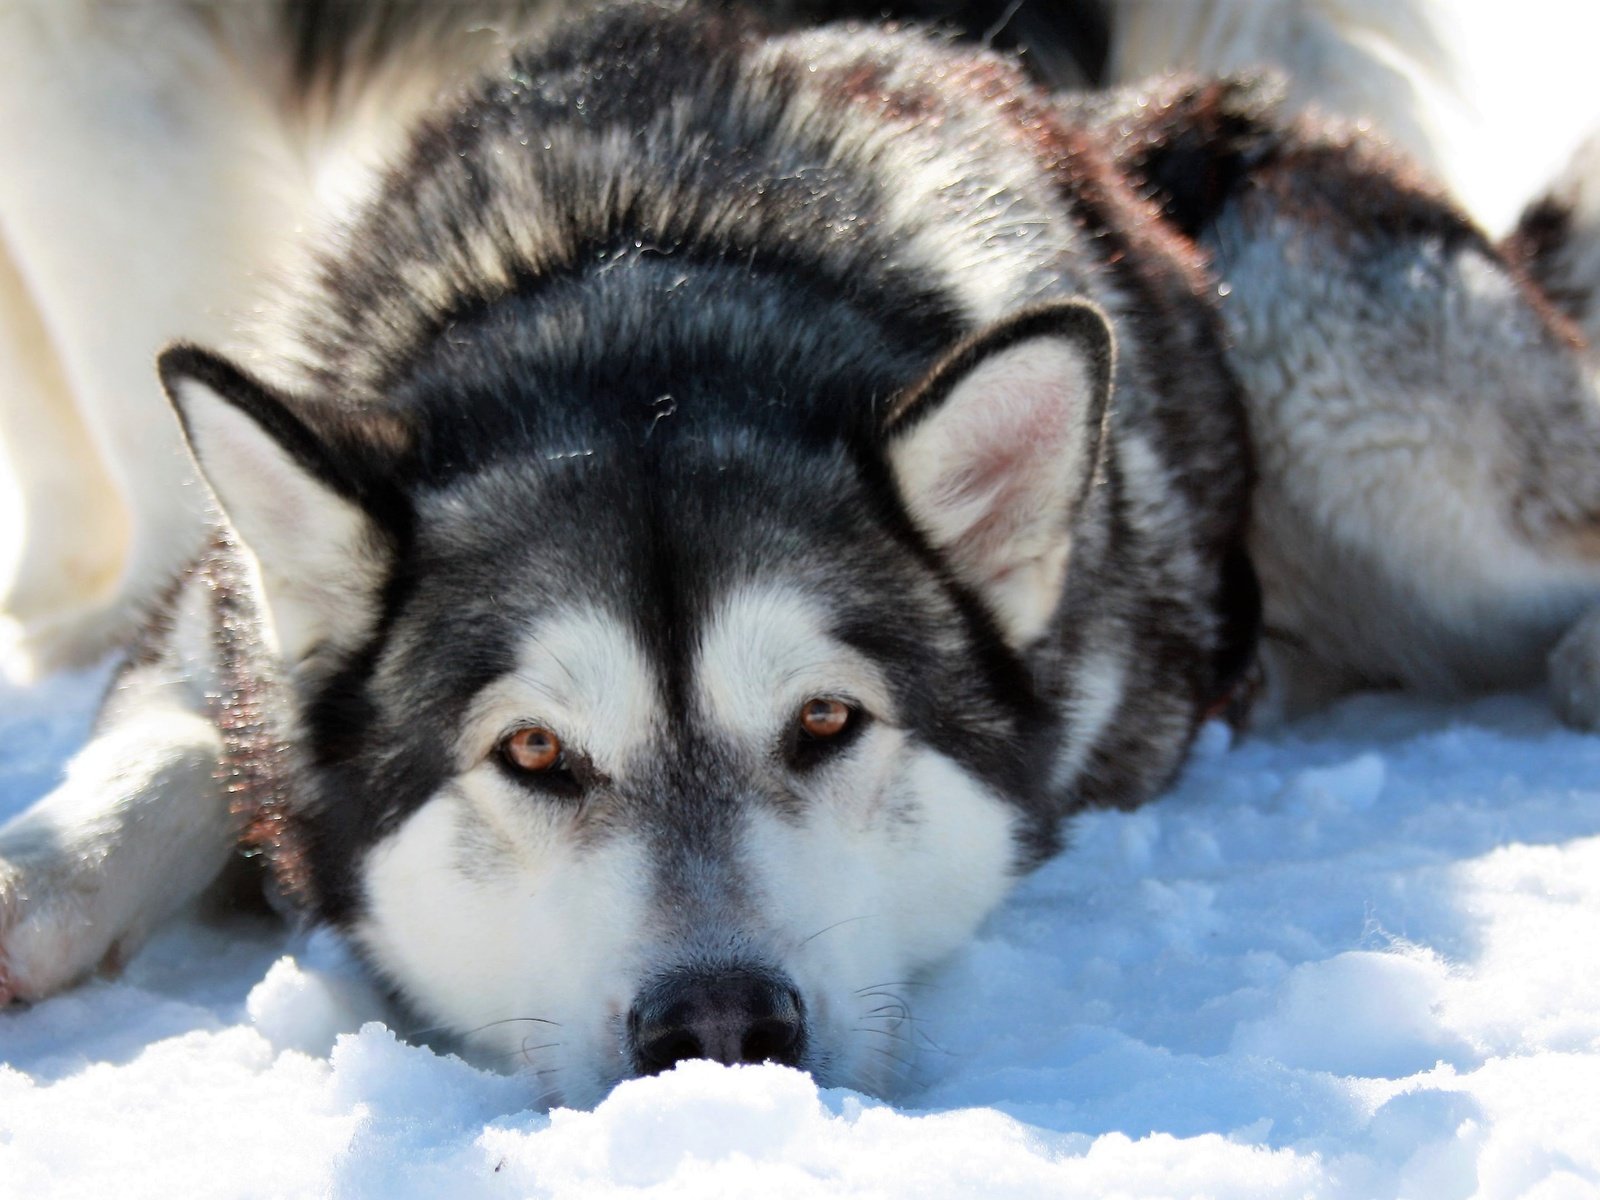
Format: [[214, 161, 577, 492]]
[[0, 664, 238, 1005]]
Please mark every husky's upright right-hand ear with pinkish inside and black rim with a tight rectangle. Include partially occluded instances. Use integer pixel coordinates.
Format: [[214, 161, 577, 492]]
[[888, 301, 1115, 648]]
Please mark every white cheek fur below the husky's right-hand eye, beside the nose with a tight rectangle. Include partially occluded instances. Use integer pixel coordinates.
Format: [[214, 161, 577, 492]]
[[744, 738, 1016, 1094]]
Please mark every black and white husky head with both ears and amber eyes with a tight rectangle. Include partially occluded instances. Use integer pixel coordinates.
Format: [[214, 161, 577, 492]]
[[163, 296, 1110, 1104]]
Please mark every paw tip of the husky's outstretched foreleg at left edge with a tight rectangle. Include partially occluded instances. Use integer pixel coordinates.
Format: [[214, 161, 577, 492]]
[[0, 858, 130, 1008]]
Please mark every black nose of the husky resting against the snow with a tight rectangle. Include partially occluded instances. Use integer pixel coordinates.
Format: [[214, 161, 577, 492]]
[[627, 968, 805, 1075]]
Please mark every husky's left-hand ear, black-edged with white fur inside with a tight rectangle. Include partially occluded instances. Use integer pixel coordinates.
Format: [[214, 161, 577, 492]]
[[157, 344, 406, 662]]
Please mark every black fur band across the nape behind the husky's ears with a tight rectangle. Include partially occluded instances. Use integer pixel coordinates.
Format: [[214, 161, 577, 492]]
[[379, 254, 934, 488]]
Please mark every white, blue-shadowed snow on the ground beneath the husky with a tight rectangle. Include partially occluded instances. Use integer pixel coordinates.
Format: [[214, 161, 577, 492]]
[[0, 675, 1600, 1200]]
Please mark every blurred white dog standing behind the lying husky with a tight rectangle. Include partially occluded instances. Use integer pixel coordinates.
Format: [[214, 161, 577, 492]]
[[0, 0, 1587, 678]]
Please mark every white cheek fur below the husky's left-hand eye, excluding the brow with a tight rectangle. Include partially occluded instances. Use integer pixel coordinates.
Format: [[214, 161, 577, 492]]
[[355, 780, 650, 1104]]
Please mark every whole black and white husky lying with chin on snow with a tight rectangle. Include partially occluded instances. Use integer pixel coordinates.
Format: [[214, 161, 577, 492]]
[[9, 5, 1600, 1104]]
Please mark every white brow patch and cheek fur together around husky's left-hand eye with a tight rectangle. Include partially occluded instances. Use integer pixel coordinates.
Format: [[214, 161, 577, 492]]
[[357, 611, 661, 1104]]
